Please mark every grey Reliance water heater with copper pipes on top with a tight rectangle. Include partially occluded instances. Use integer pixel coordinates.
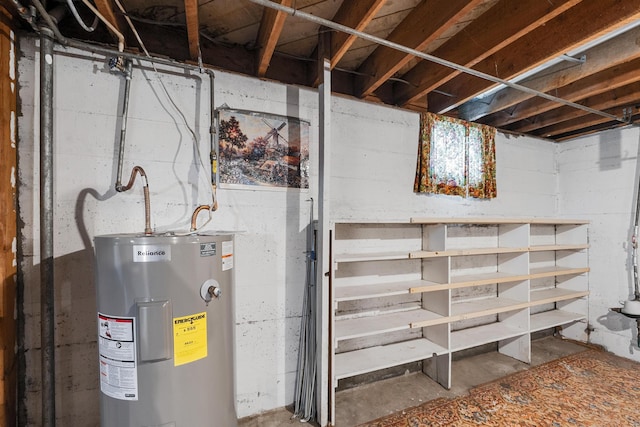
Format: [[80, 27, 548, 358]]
[[95, 234, 237, 427]]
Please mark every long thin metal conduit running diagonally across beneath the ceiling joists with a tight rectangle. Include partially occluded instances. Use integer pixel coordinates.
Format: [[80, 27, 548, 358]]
[[249, 0, 628, 123]]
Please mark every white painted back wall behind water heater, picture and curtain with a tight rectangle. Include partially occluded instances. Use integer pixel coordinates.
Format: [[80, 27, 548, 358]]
[[19, 39, 558, 425]]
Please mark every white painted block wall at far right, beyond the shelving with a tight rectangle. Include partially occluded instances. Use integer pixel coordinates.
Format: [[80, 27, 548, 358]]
[[558, 127, 640, 360]]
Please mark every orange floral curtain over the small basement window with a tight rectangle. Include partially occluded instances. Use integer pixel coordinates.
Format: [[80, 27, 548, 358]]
[[413, 113, 497, 199]]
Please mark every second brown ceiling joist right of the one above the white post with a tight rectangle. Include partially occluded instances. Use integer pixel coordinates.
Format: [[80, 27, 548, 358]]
[[396, 0, 581, 106]]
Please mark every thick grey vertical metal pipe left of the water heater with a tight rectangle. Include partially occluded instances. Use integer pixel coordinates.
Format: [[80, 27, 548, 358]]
[[40, 28, 56, 427]]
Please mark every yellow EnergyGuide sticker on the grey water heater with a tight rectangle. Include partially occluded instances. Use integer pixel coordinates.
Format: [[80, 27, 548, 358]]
[[173, 312, 207, 366]]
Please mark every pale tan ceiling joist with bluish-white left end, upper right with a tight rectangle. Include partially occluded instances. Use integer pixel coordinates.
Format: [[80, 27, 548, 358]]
[[460, 28, 640, 121]]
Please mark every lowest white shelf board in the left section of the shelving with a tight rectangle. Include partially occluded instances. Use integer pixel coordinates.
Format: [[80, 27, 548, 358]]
[[335, 338, 447, 380]]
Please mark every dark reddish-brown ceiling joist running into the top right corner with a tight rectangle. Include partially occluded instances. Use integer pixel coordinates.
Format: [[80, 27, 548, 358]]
[[429, 0, 640, 113]]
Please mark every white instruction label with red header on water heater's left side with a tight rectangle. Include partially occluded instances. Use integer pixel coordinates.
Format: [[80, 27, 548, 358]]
[[98, 313, 138, 400]]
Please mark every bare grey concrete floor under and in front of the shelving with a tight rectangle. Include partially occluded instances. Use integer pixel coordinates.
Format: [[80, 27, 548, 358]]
[[239, 336, 585, 427]]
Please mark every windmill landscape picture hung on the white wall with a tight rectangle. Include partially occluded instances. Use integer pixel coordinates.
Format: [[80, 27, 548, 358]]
[[218, 109, 309, 189]]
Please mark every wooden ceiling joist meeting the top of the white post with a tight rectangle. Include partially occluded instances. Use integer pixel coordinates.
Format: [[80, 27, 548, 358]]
[[309, 0, 386, 87]]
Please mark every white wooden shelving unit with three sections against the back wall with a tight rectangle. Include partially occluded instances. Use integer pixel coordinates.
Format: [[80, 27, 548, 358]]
[[330, 218, 589, 412]]
